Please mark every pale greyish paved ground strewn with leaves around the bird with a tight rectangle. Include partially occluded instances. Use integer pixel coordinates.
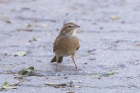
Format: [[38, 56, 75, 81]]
[[0, 0, 140, 93]]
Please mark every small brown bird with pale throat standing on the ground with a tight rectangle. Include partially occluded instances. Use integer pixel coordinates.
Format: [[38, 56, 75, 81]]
[[51, 22, 80, 70]]
